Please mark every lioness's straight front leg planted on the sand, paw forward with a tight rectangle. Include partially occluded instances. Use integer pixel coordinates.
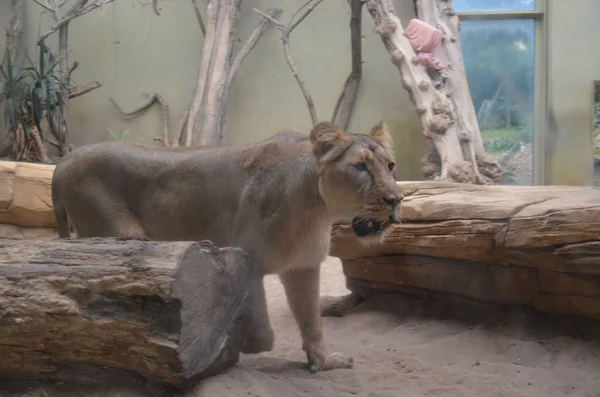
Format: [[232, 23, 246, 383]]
[[280, 267, 354, 373]]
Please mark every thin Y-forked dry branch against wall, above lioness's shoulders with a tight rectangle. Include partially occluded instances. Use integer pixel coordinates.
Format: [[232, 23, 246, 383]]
[[253, 0, 323, 125]]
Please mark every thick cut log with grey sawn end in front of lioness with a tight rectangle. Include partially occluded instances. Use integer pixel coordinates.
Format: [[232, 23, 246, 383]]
[[0, 238, 253, 387]]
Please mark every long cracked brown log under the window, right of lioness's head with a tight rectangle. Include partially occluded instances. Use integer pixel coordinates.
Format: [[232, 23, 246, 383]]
[[330, 182, 600, 318]]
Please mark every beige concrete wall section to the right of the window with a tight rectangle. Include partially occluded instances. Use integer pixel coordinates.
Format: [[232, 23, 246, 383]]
[[546, 0, 600, 185]]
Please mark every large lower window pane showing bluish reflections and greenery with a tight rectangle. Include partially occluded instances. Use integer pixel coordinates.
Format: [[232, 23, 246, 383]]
[[460, 19, 535, 185]]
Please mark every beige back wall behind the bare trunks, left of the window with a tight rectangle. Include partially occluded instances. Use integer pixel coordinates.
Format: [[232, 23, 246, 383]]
[[0, 0, 424, 179]]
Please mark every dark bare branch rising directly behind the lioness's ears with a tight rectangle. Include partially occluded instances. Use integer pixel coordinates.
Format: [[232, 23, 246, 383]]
[[331, 0, 363, 129]]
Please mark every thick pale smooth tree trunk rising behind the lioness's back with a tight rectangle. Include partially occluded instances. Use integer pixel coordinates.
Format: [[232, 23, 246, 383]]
[[185, 0, 242, 146]]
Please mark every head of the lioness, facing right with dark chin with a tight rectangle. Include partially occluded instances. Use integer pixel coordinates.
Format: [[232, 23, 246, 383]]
[[310, 122, 404, 238]]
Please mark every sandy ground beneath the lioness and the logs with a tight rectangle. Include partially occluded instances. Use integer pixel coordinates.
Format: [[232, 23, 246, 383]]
[[0, 258, 600, 397]]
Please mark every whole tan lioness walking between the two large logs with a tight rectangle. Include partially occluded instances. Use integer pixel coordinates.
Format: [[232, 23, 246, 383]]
[[52, 122, 403, 372]]
